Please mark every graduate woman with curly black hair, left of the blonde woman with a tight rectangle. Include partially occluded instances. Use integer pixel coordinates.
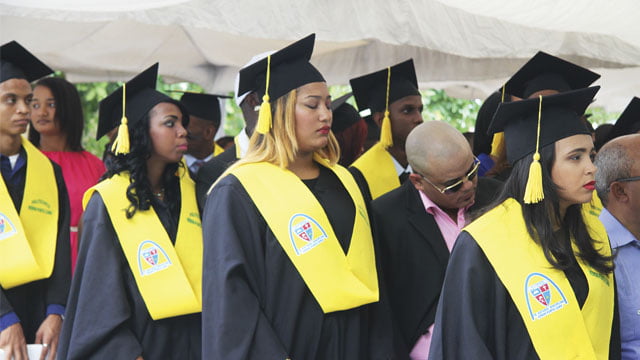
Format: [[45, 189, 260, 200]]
[[59, 64, 202, 360]]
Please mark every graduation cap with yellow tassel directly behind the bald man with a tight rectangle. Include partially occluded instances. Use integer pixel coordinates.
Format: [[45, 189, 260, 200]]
[[349, 59, 420, 148]]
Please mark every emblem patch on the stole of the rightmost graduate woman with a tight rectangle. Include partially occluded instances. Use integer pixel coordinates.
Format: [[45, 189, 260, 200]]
[[524, 273, 567, 320]]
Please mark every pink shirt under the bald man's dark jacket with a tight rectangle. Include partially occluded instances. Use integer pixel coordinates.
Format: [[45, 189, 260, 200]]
[[409, 191, 471, 360]]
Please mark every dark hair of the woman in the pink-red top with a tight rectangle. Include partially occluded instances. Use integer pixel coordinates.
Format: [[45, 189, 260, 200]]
[[29, 77, 84, 151]]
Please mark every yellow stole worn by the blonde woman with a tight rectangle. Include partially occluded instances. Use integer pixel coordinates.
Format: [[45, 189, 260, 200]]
[[231, 158, 378, 313]]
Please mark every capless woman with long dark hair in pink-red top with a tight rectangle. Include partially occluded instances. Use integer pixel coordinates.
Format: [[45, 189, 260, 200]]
[[29, 77, 105, 271]]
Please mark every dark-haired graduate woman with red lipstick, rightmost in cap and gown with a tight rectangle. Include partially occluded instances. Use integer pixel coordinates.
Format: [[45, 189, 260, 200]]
[[429, 87, 620, 360]]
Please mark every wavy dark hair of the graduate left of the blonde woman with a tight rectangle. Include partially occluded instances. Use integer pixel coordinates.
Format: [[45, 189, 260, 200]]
[[101, 100, 189, 219]]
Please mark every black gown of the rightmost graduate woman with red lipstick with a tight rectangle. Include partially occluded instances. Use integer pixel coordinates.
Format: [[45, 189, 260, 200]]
[[429, 231, 620, 360]]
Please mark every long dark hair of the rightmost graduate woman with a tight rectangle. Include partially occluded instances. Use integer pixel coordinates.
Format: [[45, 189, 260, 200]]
[[487, 143, 613, 274]]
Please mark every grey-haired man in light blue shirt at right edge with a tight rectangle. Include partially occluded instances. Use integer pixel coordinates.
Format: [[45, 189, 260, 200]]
[[595, 134, 640, 360]]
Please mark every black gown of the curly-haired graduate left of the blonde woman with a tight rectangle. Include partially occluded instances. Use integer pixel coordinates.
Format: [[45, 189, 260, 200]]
[[58, 192, 201, 360]]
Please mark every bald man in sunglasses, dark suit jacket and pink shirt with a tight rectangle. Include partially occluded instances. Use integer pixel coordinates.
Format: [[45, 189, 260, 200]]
[[372, 121, 501, 359]]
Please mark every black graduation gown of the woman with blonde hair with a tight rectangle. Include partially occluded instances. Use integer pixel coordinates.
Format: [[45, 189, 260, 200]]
[[202, 167, 393, 360]]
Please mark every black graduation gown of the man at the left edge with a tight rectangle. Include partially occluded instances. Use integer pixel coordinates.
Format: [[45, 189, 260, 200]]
[[0, 153, 71, 343]]
